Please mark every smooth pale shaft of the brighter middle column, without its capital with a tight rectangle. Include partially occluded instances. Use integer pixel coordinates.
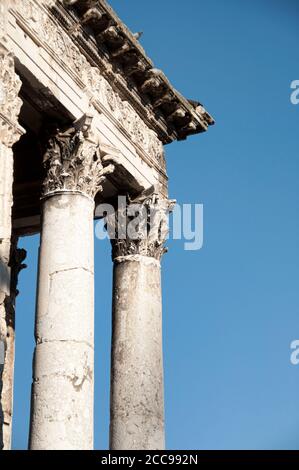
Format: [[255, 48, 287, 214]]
[[29, 193, 94, 450]]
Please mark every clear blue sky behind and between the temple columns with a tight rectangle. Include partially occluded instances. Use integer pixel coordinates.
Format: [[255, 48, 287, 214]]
[[13, 0, 299, 449]]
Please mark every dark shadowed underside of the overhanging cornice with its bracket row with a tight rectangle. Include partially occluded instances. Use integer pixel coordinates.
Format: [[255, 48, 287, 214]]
[[54, 0, 214, 143]]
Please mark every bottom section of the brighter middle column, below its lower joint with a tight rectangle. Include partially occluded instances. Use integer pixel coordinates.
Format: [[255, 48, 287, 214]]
[[30, 340, 93, 450]]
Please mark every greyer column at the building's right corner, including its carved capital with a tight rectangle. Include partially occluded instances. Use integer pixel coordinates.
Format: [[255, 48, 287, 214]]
[[108, 195, 173, 450]]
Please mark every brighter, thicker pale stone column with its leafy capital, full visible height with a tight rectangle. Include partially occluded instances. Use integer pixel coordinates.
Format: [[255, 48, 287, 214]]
[[29, 117, 114, 450]]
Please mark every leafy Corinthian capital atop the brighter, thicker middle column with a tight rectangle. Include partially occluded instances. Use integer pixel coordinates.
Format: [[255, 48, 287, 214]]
[[43, 115, 117, 198]]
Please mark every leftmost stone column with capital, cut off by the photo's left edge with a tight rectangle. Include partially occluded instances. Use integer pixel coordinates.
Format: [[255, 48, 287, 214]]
[[0, 36, 24, 449]]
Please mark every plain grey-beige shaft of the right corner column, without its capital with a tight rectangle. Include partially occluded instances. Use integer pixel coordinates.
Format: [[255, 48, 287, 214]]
[[110, 255, 165, 450]]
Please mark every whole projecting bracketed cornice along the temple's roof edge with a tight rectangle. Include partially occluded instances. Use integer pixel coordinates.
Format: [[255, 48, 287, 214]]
[[51, 0, 214, 144]]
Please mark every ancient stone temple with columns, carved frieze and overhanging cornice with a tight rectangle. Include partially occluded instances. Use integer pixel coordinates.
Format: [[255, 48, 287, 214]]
[[0, 0, 213, 450]]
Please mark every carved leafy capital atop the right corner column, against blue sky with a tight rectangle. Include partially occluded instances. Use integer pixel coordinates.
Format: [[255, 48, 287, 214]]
[[107, 191, 176, 261]]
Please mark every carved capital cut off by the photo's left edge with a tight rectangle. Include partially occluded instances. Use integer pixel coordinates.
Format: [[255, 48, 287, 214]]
[[0, 45, 24, 147]]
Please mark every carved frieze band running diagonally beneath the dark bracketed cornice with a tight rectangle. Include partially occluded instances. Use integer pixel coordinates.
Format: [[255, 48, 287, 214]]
[[15, 0, 165, 169]]
